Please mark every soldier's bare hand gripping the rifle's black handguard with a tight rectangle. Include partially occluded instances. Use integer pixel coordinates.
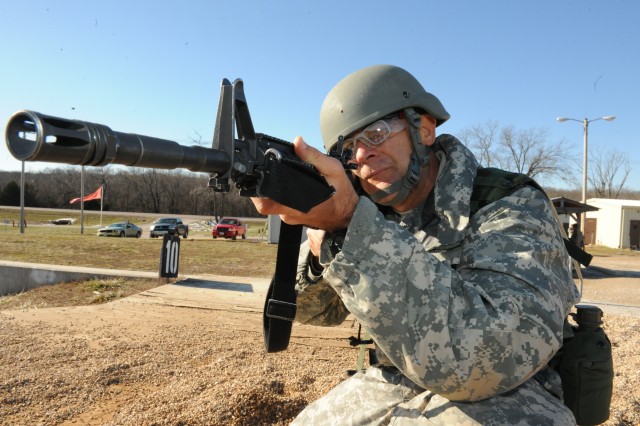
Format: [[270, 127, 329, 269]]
[[251, 136, 359, 232]]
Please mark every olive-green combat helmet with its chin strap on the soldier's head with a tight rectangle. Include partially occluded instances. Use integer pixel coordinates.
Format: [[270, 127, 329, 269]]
[[320, 65, 450, 205]]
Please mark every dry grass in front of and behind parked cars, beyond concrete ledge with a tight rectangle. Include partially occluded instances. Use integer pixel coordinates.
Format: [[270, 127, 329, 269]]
[[0, 208, 277, 277]]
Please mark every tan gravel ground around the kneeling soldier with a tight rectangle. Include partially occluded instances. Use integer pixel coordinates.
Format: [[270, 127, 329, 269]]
[[0, 255, 640, 425]]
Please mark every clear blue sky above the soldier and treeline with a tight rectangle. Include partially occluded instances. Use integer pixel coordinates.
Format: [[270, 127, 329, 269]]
[[0, 0, 640, 190]]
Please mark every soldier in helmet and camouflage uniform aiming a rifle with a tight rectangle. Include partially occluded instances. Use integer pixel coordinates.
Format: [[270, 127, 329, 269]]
[[253, 65, 579, 425]]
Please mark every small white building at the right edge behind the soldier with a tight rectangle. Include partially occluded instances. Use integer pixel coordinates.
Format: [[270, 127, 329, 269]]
[[585, 198, 640, 250]]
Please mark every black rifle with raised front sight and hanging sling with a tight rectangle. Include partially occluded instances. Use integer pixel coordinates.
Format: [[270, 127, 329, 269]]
[[6, 79, 351, 352]]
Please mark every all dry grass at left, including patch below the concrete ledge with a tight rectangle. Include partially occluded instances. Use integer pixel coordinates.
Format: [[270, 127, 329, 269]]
[[0, 209, 277, 310]]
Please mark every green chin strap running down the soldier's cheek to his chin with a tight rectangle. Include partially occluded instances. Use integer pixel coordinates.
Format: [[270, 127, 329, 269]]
[[370, 108, 431, 206]]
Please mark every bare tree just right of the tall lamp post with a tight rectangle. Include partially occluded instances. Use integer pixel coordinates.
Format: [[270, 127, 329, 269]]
[[588, 150, 631, 198]]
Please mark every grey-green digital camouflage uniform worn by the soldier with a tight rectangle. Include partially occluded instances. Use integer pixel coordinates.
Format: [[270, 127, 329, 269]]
[[294, 135, 579, 425]]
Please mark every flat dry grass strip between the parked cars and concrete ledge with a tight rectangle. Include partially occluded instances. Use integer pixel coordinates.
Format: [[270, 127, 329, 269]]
[[0, 227, 277, 278]]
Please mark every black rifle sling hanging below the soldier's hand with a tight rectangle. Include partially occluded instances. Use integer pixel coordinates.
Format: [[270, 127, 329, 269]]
[[262, 222, 302, 353]]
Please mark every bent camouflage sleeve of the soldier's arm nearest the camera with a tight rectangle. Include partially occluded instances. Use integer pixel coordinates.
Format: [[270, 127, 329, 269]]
[[324, 187, 577, 401]]
